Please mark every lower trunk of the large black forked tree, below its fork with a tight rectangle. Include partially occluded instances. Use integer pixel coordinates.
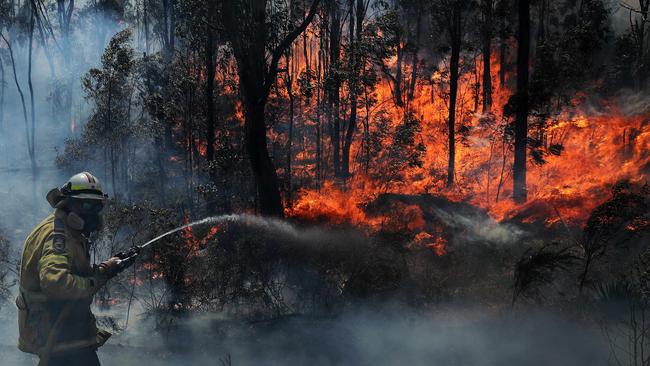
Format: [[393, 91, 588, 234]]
[[245, 101, 283, 216]]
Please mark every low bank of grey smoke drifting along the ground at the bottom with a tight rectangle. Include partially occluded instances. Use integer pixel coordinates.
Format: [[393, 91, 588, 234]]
[[0, 304, 608, 366]]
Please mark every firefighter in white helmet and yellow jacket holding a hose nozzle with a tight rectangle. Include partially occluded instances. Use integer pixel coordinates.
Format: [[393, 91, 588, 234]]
[[16, 172, 135, 366]]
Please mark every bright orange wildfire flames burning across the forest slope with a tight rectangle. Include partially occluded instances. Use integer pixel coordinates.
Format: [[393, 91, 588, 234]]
[[286, 46, 650, 234]]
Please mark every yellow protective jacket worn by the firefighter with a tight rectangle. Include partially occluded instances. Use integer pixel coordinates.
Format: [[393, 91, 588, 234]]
[[16, 209, 110, 357]]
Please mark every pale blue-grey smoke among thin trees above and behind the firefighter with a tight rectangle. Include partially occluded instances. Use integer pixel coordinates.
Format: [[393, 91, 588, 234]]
[[0, 5, 130, 243]]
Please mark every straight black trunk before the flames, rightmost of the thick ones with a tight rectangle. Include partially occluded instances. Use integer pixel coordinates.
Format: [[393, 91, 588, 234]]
[[513, 0, 530, 203]]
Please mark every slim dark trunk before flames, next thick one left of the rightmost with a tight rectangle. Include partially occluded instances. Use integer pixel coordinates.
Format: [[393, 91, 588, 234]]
[[447, 3, 461, 187]]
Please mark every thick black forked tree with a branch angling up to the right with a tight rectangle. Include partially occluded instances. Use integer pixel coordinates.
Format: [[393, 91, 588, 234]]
[[221, 0, 320, 216]]
